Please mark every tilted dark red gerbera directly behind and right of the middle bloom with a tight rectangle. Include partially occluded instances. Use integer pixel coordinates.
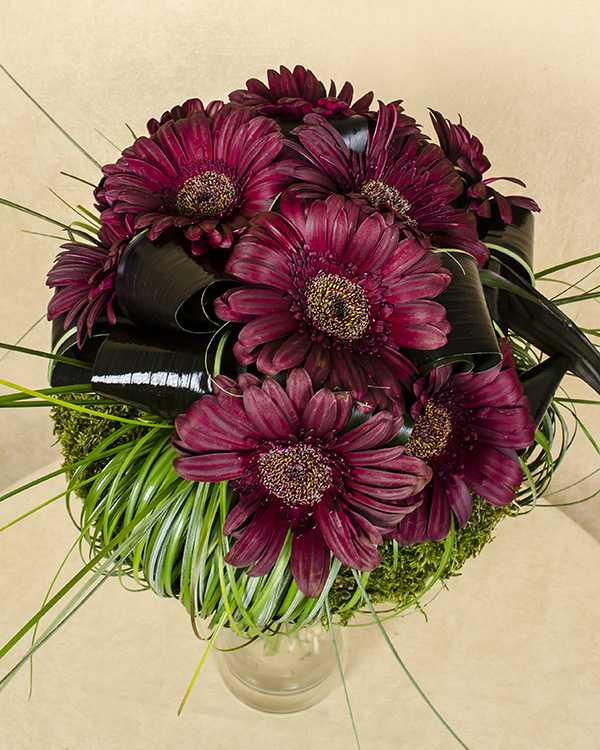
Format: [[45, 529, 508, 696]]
[[292, 103, 489, 265]]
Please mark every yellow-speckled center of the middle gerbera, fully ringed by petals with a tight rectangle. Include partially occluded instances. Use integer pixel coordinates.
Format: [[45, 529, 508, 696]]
[[306, 271, 371, 341]]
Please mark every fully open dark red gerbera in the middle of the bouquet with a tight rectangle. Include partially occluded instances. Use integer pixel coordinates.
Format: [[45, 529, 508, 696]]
[[215, 195, 450, 400]]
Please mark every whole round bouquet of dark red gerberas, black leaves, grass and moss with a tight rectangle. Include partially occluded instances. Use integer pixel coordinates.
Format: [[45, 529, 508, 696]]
[[0, 66, 600, 748]]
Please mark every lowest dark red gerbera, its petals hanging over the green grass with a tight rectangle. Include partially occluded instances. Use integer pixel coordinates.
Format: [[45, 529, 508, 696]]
[[173, 370, 431, 597]]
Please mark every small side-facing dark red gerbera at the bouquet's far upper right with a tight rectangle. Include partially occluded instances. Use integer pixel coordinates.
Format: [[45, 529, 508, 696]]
[[430, 109, 540, 224]]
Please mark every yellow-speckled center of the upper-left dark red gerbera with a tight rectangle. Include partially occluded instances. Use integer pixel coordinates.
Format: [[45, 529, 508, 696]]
[[175, 171, 237, 219]]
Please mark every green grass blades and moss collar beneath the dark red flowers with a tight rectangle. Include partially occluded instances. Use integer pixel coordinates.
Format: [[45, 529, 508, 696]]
[[52, 394, 506, 633]]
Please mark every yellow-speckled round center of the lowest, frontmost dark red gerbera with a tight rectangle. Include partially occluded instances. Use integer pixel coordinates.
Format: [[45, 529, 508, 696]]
[[258, 444, 333, 506]]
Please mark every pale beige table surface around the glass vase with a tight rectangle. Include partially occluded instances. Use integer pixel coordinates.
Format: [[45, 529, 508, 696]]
[[0, 465, 600, 750]]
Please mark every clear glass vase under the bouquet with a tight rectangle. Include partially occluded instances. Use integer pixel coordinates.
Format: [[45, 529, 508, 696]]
[[215, 624, 342, 713]]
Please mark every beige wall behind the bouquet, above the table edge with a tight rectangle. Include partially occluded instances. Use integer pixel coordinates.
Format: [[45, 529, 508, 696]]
[[0, 0, 600, 535]]
